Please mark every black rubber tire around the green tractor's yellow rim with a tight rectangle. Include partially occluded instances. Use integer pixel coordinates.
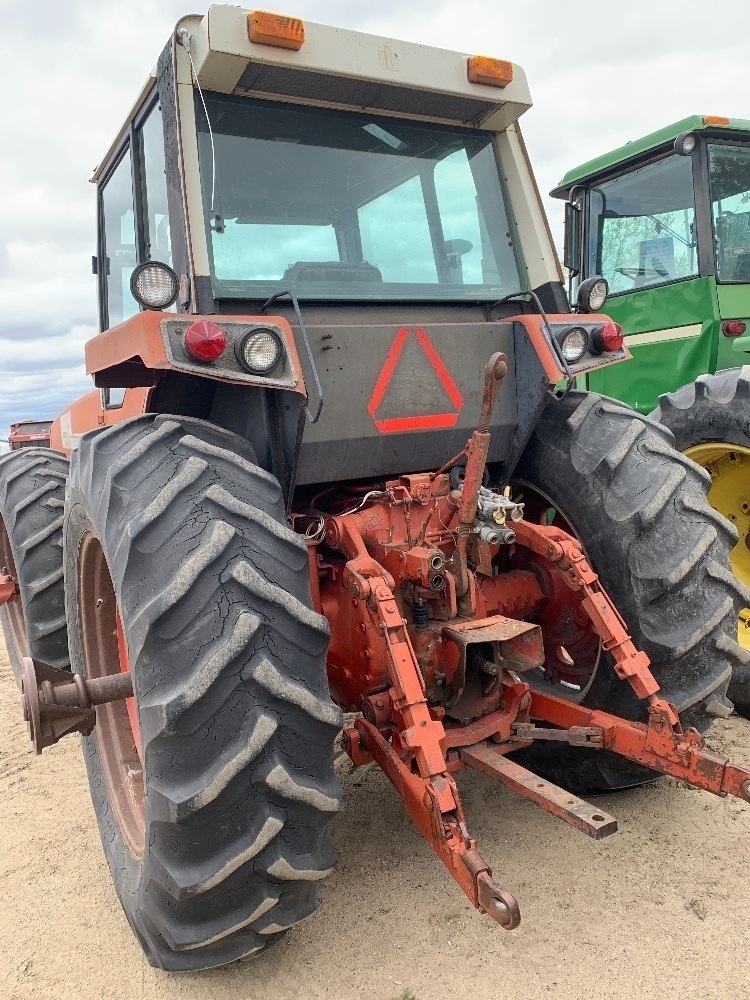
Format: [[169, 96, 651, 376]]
[[651, 365, 750, 718]]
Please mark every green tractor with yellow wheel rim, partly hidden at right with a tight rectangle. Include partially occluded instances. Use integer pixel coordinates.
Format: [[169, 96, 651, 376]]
[[552, 116, 750, 696]]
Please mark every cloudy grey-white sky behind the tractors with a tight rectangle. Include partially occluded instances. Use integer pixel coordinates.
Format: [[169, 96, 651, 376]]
[[0, 0, 750, 446]]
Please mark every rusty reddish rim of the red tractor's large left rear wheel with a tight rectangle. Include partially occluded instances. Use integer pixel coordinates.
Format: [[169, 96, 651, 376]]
[[78, 532, 146, 858]]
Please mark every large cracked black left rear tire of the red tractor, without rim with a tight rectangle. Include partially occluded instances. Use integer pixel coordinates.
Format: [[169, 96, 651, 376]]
[[65, 414, 343, 970]]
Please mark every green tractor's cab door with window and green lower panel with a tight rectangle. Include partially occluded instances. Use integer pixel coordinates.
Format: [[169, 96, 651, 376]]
[[585, 153, 718, 413]]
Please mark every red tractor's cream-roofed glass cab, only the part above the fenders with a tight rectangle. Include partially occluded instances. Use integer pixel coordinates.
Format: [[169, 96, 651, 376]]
[[93, 6, 540, 329]]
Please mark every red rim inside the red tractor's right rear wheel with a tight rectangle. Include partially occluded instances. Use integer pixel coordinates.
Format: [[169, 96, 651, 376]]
[[511, 480, 601, 702]]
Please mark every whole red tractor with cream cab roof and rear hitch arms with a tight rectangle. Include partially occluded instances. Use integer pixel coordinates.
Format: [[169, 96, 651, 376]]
[[0, 6, 750, 969]]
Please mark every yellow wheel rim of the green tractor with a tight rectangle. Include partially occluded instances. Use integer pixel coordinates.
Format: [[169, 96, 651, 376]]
[[685, 441, 750, 650]]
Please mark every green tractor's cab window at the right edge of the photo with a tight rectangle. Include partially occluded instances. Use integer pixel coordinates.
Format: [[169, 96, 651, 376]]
[[708, 144, 750, 282]]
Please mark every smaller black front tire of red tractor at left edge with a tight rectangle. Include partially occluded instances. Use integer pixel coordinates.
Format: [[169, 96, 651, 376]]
[[0, 448, 70, 687]]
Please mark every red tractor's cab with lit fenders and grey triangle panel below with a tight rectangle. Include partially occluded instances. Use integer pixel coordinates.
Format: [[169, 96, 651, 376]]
[[83, 6, 626, 503]]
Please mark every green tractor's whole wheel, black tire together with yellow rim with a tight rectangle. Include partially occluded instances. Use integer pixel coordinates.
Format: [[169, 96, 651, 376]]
[[651, 366, 750, 718]]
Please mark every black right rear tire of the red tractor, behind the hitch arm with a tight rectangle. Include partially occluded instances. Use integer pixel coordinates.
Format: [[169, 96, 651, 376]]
[[513, 392, 747, 794]]
